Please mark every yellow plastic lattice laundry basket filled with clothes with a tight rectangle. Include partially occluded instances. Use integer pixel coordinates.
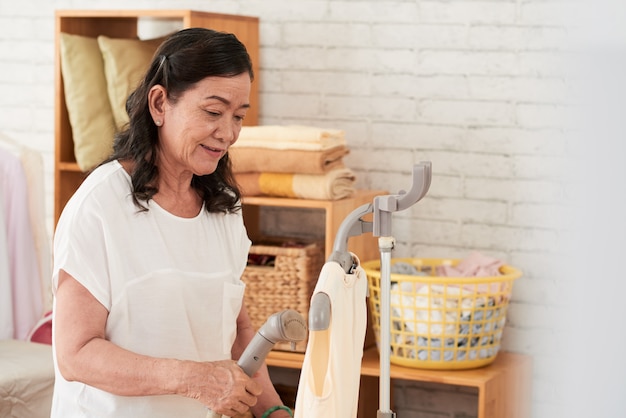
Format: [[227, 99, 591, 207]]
[[362, 258, 522, 370]]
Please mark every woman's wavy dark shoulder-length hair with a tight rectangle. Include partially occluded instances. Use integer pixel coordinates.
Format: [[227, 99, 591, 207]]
[[107, 28, 254, 213]]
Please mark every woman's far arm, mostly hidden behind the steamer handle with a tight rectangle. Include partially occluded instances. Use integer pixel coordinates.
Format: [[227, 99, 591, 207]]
[[232, 306, 291, 418]]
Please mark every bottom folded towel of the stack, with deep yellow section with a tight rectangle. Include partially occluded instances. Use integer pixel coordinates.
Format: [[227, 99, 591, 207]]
[[235, 168, 356, 200]]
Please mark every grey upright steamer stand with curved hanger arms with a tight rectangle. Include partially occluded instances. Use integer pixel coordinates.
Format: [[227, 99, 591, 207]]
[[309, 162, 432, 418]]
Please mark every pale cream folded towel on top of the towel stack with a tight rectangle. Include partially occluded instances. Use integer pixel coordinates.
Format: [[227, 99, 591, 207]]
[[233, 125, 346, 151]]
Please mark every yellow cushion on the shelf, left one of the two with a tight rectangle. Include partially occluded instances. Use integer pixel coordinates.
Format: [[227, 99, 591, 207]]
[[60, 33, 115, 171]]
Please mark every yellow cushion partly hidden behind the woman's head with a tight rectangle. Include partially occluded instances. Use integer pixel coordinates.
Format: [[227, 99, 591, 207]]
[[98, 35, 164, 129]]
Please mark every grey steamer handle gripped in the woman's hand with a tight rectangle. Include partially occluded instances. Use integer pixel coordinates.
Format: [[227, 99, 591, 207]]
[[207, 309, 307, 418]]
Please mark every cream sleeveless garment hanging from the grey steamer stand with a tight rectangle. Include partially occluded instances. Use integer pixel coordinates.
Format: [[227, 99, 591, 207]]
[[295, 255, 367, 418]]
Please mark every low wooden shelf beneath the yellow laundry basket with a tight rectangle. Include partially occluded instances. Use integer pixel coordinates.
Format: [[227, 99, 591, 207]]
[[266, 347, 532, 418]]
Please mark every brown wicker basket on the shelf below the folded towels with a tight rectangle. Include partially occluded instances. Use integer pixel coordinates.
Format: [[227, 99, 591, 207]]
[[242, 243, 324, 353]]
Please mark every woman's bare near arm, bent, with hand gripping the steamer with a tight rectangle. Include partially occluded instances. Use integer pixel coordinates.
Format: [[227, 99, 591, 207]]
[[54, 270, 261, 416]]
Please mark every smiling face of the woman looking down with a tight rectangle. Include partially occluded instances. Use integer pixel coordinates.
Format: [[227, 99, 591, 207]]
[[155, 73, 251, 176]]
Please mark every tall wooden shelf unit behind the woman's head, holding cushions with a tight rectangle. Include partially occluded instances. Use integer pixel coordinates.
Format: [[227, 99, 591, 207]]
[[54, 10, 259, 225]]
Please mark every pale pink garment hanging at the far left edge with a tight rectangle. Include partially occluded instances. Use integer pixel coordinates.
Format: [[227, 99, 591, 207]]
[[0, 148, 43, 340]]
